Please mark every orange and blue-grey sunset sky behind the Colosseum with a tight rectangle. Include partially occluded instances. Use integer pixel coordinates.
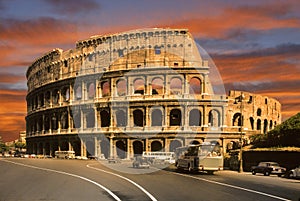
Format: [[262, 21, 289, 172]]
[[0, 0, 300, 141]]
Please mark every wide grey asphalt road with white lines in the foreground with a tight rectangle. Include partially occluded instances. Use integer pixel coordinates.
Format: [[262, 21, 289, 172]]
[[0, 158, 300, 201]]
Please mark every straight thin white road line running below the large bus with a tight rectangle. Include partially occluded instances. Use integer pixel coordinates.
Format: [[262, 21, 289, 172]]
[[172, 172, 291, 201]]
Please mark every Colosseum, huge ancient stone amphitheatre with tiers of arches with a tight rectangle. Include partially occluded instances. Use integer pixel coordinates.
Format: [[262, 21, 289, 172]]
[[26, 28, 281, 159]]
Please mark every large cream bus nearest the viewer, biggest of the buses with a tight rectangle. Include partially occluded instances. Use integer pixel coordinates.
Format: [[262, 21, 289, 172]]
[[175, 142, 224, 174]]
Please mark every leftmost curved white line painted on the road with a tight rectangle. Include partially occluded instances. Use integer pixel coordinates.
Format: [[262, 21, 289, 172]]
[[1, 160, 121, 201]]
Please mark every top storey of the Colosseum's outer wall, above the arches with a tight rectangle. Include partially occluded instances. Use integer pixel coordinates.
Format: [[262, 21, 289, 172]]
[[26, 28, 208, 92]]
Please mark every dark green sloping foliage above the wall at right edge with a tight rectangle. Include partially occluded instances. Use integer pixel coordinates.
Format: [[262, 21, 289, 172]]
[[251, 113, 300, 147]]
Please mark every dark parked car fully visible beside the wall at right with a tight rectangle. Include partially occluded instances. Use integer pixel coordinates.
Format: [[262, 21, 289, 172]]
[[251, 162, 286, 177]]
